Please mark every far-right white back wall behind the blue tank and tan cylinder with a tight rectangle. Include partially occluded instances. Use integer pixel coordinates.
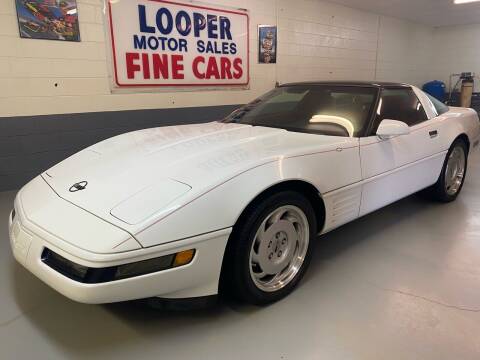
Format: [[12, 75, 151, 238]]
[[430, 24, 480, 91]]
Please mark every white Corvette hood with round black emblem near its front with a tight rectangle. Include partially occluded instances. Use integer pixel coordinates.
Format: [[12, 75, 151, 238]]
[[42, 122, 345, 233]]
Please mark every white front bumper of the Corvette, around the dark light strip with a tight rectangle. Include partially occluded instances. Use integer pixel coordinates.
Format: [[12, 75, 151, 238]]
[[9, 197, 231, 304]]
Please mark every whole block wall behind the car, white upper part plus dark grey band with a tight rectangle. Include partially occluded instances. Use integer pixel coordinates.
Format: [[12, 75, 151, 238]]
[[0, 0, 438, 191]]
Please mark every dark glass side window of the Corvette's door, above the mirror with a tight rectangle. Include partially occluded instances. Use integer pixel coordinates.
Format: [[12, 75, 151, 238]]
[[373, 88, 427, 132]]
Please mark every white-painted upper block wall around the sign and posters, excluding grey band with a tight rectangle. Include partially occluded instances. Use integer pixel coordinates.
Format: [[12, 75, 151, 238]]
[[0, 0, 433, 116]]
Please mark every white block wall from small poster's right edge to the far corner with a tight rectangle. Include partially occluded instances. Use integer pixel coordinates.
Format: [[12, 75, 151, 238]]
[[277, 0, 433, 85]]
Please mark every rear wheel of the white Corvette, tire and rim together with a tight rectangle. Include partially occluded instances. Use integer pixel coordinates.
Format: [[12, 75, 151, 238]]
[[430, 139, 468, 203]]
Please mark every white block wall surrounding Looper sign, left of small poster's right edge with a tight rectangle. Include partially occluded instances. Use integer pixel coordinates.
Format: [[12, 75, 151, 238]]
[[0, 0, 276, 116]]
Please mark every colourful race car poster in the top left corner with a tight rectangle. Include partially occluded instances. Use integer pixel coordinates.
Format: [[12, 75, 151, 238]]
[[15, 0, 80, 41]]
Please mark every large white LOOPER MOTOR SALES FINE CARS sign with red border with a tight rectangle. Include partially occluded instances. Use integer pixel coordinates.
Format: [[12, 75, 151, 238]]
[[107, 0, 249, 89]]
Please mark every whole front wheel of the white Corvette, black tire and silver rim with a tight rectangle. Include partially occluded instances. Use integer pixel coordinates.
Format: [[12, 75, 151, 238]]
[[222, 191, 317, 305]]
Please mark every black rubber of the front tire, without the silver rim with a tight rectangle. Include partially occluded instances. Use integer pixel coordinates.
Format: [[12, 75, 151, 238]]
[[230, 191, 317, 305]]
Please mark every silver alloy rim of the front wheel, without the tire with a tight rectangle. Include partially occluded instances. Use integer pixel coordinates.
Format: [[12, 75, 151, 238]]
[[250, 205, 310, 292]]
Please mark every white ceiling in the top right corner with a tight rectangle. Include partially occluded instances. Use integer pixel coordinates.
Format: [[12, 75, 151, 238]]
[[330, 0, 480, 26]]
